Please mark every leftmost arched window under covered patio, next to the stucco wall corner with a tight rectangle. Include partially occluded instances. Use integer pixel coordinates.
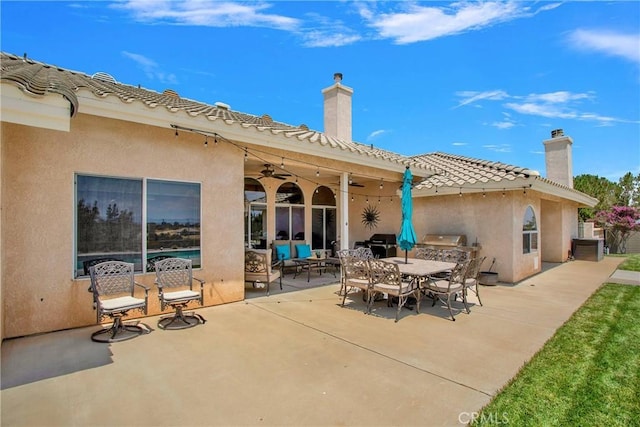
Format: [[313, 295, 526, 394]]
[[244, 178, 267, 249]]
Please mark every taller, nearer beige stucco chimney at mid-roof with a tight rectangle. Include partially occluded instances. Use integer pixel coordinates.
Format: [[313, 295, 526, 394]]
[[322, 73, 353, 142]]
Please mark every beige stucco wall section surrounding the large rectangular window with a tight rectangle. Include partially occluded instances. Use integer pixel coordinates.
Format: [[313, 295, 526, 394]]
[[0, 114, 244, 338]]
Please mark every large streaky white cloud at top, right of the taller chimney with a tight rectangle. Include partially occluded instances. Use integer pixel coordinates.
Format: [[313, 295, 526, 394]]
[[360, 1, 549, 44]]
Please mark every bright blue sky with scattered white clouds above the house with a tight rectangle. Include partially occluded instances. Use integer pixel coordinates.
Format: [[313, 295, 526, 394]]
[[0, 0, 640, 181]]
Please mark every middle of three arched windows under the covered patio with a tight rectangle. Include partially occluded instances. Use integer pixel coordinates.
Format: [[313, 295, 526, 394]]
[[276, 182, 305, 240]]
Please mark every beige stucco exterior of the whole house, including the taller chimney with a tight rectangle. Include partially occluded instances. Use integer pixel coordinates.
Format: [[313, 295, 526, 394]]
[[0, 54, 595, 339]]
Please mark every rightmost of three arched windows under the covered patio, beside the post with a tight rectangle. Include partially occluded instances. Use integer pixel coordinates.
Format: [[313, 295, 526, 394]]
[[311, 186, 337, 249]]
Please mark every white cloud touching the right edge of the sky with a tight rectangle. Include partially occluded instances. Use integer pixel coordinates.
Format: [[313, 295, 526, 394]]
[[569, 30, 640, 65]]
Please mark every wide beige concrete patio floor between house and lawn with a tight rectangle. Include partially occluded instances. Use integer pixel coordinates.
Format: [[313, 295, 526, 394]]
[[0, 257, 622, 426]]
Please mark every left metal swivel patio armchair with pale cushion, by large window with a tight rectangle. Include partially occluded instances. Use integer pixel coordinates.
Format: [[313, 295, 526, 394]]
[[89, 261, 149, 343]]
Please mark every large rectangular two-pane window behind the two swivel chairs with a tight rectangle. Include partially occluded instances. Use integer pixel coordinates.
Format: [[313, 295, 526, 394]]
[[74, 175, 200, 277]]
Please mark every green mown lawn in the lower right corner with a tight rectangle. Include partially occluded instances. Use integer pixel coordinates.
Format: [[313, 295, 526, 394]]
[[472, 282, 640, 427]]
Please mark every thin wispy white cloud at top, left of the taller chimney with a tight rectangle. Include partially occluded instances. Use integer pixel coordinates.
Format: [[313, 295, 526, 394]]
[[113, 0, 300, 30]]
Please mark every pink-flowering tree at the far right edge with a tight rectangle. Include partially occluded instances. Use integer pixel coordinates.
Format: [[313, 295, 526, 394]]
[[596, 206, 640, 254]]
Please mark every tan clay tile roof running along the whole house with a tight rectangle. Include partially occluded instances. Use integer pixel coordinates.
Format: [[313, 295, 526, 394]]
[[0, 52, 596, 206]]
